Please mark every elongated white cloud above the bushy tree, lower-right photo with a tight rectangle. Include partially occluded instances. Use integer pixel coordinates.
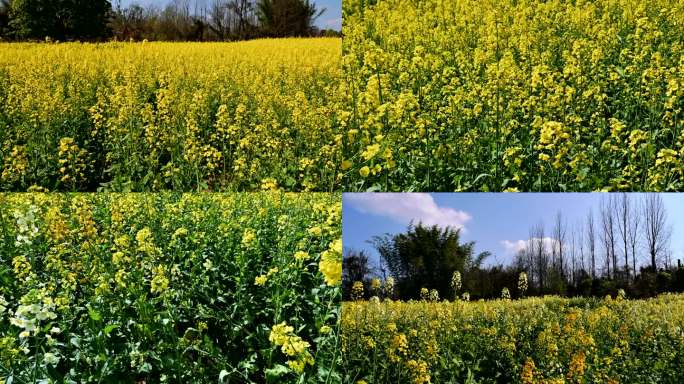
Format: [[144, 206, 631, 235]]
[[344, 193, 471, 230]]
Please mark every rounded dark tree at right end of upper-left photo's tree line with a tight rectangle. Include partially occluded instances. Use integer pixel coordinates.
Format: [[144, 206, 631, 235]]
[[257, 0, 325, 37]]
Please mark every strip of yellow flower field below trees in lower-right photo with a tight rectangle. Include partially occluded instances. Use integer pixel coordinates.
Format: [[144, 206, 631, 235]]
[[342, 294, 684, 384]]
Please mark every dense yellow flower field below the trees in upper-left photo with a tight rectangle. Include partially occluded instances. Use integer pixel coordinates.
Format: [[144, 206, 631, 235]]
[[0, 38, 341, 192]]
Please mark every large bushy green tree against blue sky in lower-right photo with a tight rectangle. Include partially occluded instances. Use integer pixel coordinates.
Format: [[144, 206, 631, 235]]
[[371, 223, 489, 299]]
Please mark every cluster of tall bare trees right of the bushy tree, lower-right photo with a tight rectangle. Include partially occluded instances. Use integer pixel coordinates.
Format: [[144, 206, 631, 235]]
[[515, 193, 672, 291]]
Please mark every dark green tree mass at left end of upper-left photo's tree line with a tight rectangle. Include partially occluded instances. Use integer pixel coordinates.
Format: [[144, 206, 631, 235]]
[[9, 0, 112, 40]]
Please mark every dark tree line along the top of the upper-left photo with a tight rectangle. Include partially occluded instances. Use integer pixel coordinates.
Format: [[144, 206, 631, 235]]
[[0, 0, 339, 41]]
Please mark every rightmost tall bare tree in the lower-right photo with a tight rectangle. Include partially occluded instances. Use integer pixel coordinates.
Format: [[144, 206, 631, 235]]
[[643, 193, 670, 271]]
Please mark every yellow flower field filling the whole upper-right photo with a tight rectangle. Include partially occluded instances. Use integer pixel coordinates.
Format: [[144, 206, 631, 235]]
[[342, 0, 684, 191]]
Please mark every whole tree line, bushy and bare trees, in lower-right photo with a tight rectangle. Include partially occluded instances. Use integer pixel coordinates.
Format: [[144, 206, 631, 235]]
[[343, 194, 684, 300]]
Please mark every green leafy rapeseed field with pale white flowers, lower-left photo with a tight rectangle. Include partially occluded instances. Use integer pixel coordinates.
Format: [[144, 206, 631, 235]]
[[0, 193, 342, 383]]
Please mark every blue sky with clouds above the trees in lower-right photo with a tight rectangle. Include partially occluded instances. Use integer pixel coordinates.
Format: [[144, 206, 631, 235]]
[[342, 193, 684, 272]]
